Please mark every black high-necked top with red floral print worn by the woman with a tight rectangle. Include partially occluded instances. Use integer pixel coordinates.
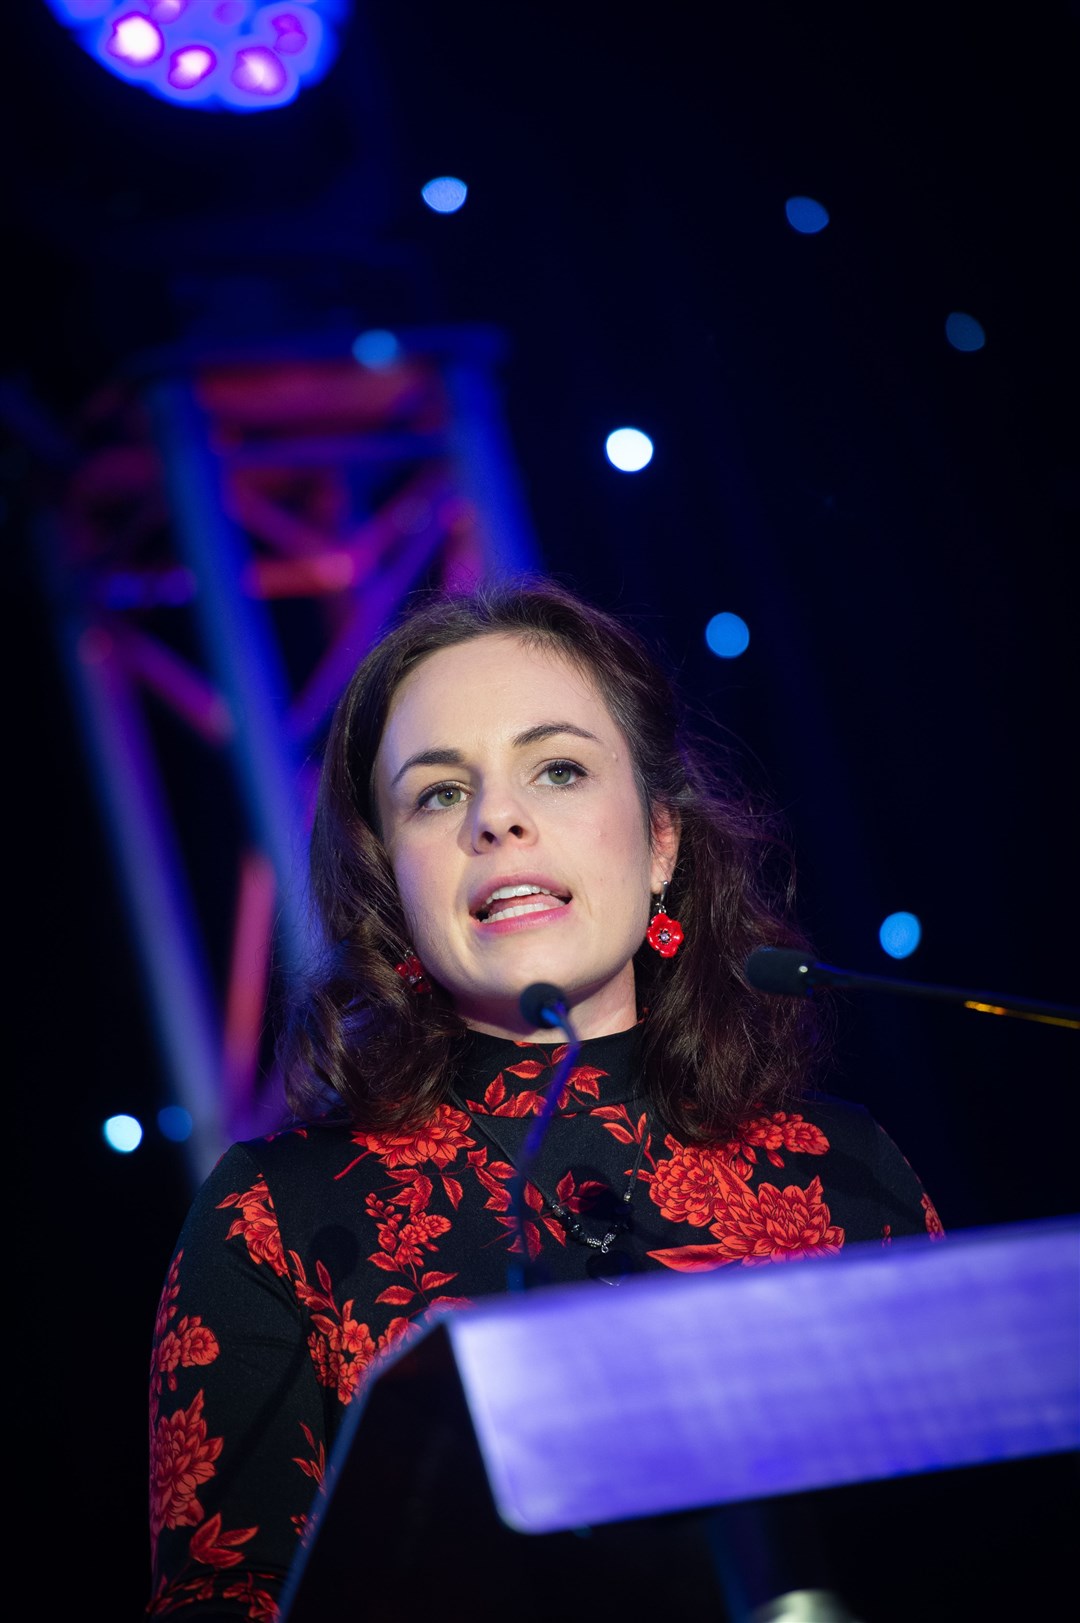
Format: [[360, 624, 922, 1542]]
[[148, 1029, 942, 1618]]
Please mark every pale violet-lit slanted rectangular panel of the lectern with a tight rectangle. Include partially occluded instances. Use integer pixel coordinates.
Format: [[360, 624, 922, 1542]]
[[445, 1219, 1080, 1534]]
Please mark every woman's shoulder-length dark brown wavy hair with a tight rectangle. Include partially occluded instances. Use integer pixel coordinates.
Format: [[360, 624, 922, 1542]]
[[279, 576, 825, 1141]]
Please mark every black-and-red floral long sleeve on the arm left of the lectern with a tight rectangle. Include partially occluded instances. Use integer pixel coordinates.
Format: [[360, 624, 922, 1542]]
[[149, 1146, 326, 1618]]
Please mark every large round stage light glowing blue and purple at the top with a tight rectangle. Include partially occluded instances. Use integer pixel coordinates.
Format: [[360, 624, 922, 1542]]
[[45, 0, 351, 112]]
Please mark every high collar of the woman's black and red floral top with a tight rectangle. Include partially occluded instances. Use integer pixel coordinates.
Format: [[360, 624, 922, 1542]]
[[455, 1021, 642, 1117]]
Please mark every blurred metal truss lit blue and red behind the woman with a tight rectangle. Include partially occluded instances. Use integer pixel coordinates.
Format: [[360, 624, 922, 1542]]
[[39, 328, 538, 1182]]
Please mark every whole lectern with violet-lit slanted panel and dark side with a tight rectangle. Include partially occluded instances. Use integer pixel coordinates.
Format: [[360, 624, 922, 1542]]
[[283, 1217, 1080, 1623]]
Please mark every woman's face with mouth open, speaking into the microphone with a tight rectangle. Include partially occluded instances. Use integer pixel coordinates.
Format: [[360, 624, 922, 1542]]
[[375, 633, 677, 1037]]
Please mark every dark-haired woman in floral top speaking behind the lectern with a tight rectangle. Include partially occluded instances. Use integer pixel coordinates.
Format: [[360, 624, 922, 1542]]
[[149, 581, 939, 1618]]
